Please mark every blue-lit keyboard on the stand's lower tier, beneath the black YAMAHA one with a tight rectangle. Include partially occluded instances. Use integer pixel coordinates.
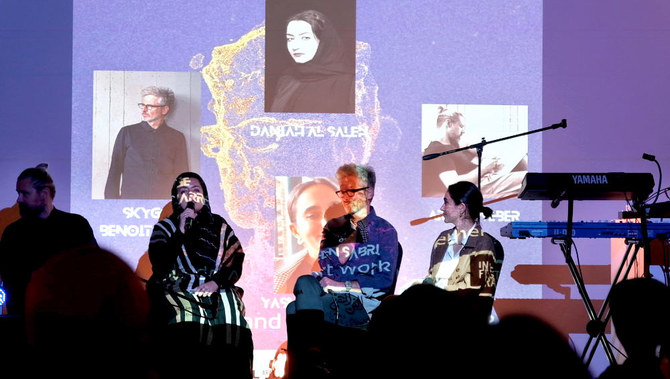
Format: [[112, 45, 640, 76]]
[[500, 221, 670, 239]]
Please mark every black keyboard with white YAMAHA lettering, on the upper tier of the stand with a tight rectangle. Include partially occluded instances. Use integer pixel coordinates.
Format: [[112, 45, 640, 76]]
[[519, 172, 654, 201]]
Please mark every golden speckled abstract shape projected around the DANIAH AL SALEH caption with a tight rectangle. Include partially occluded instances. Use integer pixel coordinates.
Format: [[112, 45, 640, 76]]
[[201, 26, 399, 243]]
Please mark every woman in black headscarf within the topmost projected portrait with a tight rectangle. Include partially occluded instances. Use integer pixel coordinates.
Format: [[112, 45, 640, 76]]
[[266, 10, 356, 113]]
